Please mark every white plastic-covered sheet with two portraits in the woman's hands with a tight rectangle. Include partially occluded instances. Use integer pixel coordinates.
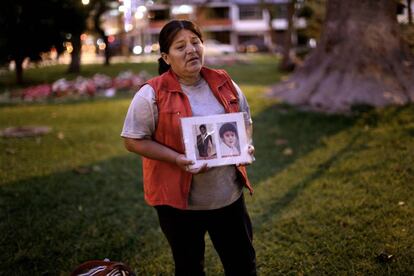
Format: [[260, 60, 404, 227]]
[[181, 112, 252, 168]]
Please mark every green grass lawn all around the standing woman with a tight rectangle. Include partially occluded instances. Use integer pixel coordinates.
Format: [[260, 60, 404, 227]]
[[0, 55, 414, 275]]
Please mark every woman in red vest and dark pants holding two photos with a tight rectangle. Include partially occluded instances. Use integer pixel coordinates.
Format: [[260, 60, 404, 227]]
[[121, 20, 256, 276]]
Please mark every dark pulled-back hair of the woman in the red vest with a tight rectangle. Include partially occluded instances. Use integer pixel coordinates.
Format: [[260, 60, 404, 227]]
[[158, 20, 203, 75]]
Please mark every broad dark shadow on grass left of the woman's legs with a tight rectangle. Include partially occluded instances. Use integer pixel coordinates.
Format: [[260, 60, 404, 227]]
[[0, 155, 169, 275]]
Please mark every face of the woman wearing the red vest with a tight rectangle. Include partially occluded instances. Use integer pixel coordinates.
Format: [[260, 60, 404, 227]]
[[161, 29, 204, 77]]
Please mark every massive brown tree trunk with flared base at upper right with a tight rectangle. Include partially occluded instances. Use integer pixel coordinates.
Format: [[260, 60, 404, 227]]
[[273, 0, 414, 112]]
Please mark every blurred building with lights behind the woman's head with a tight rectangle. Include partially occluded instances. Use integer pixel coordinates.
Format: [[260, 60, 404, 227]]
[[102, 0, 306, 54]]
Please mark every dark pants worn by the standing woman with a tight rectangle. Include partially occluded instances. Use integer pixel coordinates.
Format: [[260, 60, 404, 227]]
[[156, 196, 256, 276]]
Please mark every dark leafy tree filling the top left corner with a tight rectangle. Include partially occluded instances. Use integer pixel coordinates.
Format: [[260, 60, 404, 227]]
[[0, 0, 89, 81]]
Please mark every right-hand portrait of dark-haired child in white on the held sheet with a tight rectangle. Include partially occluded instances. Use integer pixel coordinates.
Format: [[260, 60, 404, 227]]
[[219, 122, 240, 157]]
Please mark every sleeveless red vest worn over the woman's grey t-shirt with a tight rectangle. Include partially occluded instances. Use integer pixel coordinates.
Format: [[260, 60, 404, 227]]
[[142, 67, 253, 209]]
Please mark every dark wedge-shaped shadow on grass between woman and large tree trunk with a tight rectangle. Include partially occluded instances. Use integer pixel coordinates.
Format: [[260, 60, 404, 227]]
[[248, 104, 357, 187]]
